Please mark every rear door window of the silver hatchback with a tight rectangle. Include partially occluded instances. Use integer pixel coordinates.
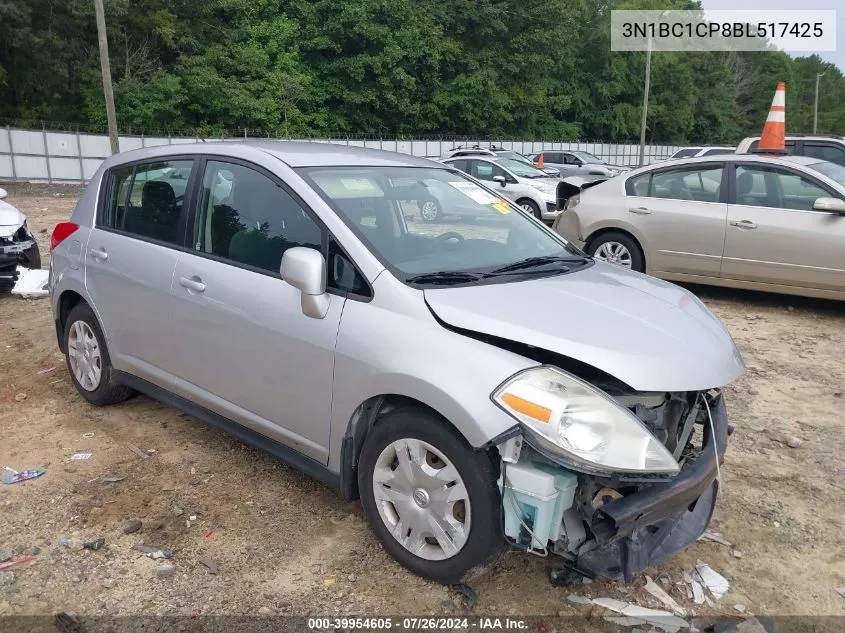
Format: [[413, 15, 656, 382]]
[[102, 160, 193, 245]]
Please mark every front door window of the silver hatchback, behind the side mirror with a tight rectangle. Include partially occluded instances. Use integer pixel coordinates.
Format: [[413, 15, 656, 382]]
[[194, 161, 323, 275]]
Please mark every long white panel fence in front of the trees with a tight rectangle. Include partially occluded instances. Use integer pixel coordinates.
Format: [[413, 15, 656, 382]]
[[0, 127, 678, 183]]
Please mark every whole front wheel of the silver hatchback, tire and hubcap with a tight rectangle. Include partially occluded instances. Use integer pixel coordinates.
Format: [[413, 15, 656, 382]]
[[358, 407, 505, 584]]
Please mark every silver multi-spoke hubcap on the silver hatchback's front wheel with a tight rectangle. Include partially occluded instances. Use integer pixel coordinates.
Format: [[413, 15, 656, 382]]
[[373, 439, 471, 560]]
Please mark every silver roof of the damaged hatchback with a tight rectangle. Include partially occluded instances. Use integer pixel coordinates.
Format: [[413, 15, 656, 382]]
[[99, 140, 444, 169]]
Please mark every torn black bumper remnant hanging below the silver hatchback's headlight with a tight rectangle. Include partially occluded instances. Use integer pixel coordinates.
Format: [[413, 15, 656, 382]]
[[576, 395, 728, 582]]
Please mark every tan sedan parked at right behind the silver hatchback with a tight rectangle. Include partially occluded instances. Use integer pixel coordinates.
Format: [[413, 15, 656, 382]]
[[554, 154, 845, 299]]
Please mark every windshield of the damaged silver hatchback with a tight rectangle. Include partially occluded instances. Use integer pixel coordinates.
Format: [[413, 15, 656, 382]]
[[298, 167, 589, 283]]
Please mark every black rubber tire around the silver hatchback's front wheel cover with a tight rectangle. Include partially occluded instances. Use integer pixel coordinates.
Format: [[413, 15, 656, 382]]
[[358, 407, 505, 584]]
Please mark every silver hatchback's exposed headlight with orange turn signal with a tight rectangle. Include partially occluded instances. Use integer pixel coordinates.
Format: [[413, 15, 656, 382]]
[[492, 367, 680, 474]]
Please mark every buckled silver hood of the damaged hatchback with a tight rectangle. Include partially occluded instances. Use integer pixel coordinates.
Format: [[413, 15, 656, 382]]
[[425, 262, 745, 391]]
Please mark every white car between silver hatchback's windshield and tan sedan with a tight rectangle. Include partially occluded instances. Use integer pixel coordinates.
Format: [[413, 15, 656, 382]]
[[442, 156, 560, 221]]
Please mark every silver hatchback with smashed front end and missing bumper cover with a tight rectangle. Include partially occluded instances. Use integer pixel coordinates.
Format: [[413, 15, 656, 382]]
[[50, 143, 743, 583]]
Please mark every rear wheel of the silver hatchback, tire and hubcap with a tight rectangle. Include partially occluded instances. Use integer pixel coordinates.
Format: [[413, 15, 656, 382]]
[[64, 303, 134, 405]]
